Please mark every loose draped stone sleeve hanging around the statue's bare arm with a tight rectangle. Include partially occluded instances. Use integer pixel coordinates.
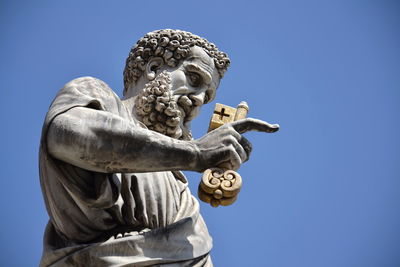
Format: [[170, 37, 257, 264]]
[[39, 77, 127, 242]]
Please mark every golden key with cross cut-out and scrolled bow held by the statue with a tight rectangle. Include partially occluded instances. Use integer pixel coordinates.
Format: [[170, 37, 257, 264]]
[[198, 101, 249, 207]]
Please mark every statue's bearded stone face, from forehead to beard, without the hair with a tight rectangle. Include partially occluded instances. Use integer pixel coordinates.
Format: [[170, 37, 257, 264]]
[[131, 47, 220, 140]]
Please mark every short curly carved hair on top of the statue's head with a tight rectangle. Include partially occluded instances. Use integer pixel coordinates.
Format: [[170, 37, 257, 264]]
[[124, 29, 230, 92]]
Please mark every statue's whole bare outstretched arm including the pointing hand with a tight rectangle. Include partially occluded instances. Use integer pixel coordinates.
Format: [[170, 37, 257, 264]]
[[47, 107, 278, 173]]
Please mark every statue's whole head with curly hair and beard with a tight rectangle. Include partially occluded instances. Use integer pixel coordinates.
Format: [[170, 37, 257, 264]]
[[124, 30, 230, 139]]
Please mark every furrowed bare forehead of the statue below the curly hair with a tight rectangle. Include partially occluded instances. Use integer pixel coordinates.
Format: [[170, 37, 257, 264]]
[[183, 46, 219, 87]]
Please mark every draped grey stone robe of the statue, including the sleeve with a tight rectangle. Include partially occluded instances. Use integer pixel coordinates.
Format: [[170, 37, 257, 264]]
[[39, 77, 212, 266]]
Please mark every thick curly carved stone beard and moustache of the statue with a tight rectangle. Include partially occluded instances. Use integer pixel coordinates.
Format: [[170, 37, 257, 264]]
[[134, 71, 199, 140]]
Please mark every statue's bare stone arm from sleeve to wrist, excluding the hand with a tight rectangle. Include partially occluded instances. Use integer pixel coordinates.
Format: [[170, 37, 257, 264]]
[[47, 108, 198, 172]]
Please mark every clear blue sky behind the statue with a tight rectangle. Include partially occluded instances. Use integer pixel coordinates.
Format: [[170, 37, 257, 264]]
[[0, 0, 400, 267]]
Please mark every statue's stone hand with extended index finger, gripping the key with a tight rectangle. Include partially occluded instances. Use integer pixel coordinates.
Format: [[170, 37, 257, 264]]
[[191, 118, 279, 171]]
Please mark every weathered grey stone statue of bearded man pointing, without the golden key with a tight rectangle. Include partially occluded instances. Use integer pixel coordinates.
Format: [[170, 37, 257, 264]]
[[40, 30, 279, 266]]
